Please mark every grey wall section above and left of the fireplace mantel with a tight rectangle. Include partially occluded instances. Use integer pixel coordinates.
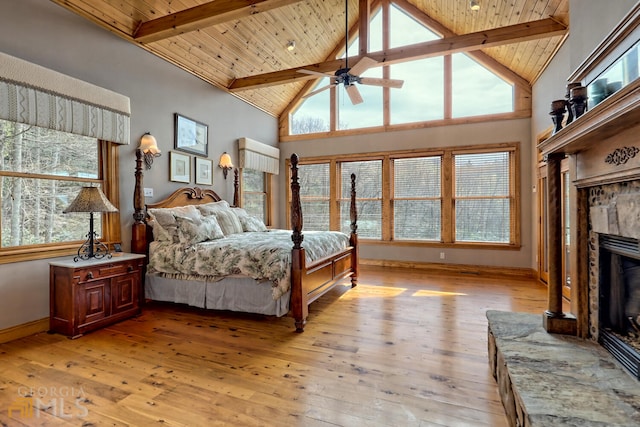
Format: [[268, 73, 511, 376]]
[[531, 0, 637, 265]]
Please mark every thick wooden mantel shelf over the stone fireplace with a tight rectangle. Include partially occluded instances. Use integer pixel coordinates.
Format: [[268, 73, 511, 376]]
[[538, 78, 640, 156]]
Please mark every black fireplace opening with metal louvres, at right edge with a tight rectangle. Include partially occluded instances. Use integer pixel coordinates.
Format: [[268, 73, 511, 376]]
[[598, 235, 640, 379]]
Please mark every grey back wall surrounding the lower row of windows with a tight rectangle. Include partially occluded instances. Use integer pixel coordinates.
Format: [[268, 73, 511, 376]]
[[280, 119, 533, 268]]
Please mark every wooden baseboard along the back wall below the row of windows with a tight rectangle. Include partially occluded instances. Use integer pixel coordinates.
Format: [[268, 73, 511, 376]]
[[359, 258, 536, 279]]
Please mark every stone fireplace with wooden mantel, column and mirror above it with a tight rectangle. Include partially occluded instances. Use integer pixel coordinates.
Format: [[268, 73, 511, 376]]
[[538, 0, 640, 379]]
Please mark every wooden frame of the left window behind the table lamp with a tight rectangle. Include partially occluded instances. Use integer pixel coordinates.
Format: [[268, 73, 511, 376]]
[[0, 139, 122, 264]]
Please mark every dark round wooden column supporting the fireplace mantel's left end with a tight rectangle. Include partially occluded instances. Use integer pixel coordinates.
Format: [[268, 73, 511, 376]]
[[543, 153, 576, 335]]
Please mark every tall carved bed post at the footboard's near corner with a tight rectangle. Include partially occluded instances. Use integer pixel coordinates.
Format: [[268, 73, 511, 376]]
[[290, 153, 309, 332]]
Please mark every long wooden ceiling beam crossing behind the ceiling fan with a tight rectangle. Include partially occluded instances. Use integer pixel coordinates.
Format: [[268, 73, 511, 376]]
[[228, 18, 567, 92]]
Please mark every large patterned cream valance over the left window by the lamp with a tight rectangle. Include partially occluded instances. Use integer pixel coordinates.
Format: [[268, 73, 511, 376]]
[[0, 52, 131, 144]]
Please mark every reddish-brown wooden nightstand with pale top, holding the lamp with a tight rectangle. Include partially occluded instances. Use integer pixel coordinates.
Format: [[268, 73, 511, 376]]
[[49, 254, 145, 338]]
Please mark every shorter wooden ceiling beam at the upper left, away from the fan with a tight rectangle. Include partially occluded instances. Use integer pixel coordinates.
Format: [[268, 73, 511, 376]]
[[133, 0, 302, 43]]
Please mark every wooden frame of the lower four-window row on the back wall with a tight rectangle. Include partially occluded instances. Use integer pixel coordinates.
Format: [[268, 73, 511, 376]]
[[286, 142, 521, 250]]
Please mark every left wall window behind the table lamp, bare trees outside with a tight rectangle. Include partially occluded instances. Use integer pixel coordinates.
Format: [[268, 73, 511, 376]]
[[0, 120, 120, 262]]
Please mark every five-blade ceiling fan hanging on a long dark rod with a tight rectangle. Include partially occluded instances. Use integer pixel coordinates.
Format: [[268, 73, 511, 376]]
[[298, 0, 404, 105]]
